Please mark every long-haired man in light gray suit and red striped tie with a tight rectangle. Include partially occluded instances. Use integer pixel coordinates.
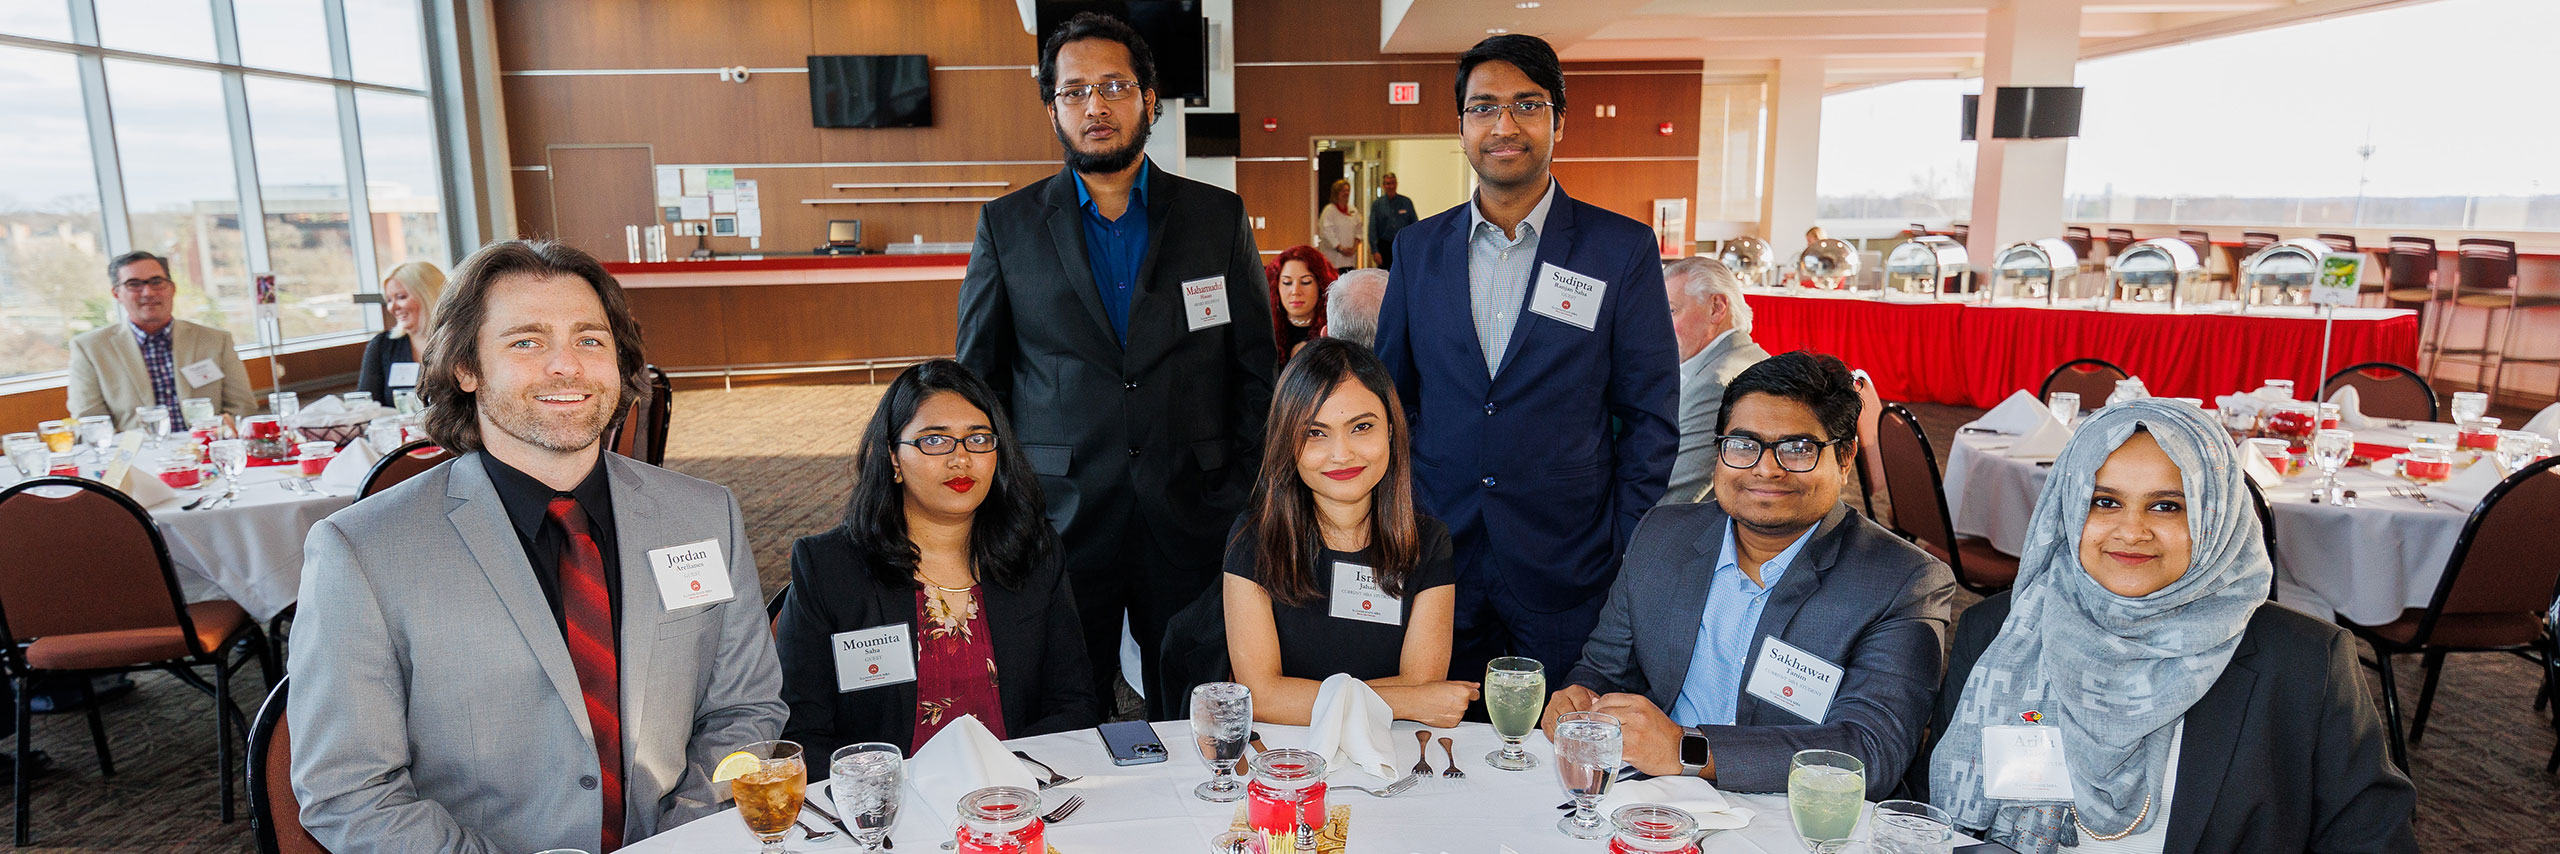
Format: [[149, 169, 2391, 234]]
[[289, 240, 786, 854]]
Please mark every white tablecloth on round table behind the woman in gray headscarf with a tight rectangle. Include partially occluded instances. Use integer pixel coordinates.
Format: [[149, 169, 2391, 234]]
[[1946, 424, 2470, 626]]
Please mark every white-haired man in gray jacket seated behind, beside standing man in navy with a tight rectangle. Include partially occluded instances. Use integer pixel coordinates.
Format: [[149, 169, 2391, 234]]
[[1661, 256, 1769, 504]]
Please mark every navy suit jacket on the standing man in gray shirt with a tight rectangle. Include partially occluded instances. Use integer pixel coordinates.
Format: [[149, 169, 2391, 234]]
[[1377, 184, 1679, 605]]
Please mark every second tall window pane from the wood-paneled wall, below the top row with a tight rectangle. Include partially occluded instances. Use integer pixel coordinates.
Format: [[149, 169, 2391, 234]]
[[248, 77, 366, 340]]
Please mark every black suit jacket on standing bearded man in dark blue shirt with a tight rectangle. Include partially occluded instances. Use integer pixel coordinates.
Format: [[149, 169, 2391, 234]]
[[960, 157, 1275, 578]]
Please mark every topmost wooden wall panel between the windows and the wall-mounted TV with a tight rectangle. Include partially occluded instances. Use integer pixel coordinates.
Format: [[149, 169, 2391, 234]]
[[492, 0, 812, 70]]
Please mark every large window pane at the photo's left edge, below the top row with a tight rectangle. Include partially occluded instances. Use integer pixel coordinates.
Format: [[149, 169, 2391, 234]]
[[0, 49, 113, 378]]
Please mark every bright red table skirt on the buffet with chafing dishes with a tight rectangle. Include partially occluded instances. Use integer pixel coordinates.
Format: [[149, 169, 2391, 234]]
[[1746, 294, 2419, 409]]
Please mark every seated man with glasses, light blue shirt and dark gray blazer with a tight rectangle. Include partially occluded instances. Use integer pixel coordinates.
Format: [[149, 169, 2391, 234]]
[[1546, 353, 1956, 798]]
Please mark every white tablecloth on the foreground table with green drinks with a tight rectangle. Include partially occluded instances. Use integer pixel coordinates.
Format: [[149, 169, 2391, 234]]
[[622, 721, 1976, 854]]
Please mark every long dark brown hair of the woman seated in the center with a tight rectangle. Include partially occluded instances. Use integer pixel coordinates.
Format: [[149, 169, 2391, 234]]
[[1239, 338, 1423, 606]]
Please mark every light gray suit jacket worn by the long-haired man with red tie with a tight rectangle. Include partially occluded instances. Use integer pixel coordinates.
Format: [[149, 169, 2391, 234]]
[[289, 455, 786, 854]]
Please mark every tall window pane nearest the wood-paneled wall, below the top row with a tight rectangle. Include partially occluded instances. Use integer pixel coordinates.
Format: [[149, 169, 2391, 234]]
[[356, 92, 453, 279]]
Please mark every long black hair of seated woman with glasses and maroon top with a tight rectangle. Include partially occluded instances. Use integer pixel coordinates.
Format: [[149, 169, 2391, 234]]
[[845, 358, 1057, 591]]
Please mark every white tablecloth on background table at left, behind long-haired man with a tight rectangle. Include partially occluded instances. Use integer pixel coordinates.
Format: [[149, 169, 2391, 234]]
[[0, 450, 356, 621]]
